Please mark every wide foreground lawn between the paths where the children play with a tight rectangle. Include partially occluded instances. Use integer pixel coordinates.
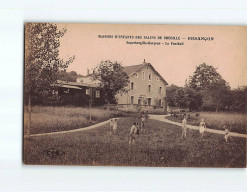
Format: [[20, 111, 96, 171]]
[[24, 117, 246, 167]]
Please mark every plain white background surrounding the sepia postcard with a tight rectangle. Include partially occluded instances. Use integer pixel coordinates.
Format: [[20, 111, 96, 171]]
[[0, 0, 247, 191]]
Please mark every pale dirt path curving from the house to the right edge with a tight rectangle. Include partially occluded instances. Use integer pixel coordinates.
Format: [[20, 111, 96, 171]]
[[149, 115, 247, 139]]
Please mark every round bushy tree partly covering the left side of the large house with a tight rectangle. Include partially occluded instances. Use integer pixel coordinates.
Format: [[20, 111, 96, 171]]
[[93, 60, 129, 104]]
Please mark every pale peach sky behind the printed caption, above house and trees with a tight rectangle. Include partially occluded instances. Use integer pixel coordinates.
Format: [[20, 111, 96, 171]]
[[58, 24, 247, 88]]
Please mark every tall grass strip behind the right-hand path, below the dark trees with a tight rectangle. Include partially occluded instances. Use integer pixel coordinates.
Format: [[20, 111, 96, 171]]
[[167, 112, 247, 134]]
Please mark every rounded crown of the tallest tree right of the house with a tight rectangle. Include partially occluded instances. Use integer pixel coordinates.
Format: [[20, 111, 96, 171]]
[[188, 63, 222, 90]]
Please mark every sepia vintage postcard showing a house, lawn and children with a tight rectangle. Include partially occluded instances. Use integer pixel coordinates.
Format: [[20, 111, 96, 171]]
[[23, 23, 247, 168]]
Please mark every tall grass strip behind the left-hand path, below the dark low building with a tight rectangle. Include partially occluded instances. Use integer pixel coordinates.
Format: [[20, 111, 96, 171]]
[[24, 106, 130, 134]]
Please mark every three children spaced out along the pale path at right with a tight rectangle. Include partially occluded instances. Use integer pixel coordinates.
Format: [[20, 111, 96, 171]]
[[182, 115, 230, 142]]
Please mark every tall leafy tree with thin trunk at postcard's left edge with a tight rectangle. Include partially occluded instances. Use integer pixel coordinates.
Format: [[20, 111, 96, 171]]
[[24, 23, 74, 136]]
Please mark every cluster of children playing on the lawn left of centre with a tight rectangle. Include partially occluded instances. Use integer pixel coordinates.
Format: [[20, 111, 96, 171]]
[[110, 115, 146, 146]]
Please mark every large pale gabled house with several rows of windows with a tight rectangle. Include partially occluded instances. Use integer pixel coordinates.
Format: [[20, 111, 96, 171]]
[[116, 60, 168, 106]]
